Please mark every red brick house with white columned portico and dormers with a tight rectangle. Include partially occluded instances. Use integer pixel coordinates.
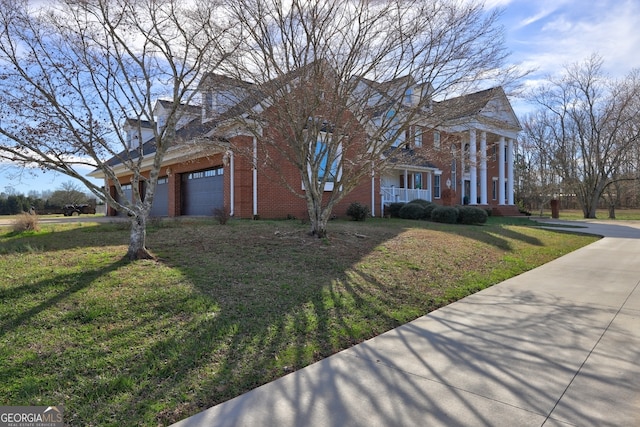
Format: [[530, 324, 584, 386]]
[[90, 70, 521, 218]]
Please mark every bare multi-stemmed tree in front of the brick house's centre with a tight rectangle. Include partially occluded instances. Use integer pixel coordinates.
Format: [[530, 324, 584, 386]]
[[208, 0, 513, 237]]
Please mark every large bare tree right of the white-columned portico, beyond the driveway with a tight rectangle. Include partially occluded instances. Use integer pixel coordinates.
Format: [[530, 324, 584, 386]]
[[530, 55, 640, 218]]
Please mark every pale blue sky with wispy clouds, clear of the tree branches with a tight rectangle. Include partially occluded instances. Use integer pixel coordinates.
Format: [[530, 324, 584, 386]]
[[0, 0, 640, 194]]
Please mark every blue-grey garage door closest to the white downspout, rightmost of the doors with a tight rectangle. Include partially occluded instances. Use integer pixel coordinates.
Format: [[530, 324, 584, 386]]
[[182, 166, 224, 216]]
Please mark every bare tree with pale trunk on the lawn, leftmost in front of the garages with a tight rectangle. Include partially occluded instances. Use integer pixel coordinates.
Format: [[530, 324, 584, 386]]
[[0, 0, 232, 259]]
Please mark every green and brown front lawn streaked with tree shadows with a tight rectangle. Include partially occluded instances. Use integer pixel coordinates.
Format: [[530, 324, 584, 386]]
[[0, 218, 595, 426]]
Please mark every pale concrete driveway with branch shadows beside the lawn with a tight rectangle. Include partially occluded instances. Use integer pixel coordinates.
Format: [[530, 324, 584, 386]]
[[174, 221, 640, 427]]
